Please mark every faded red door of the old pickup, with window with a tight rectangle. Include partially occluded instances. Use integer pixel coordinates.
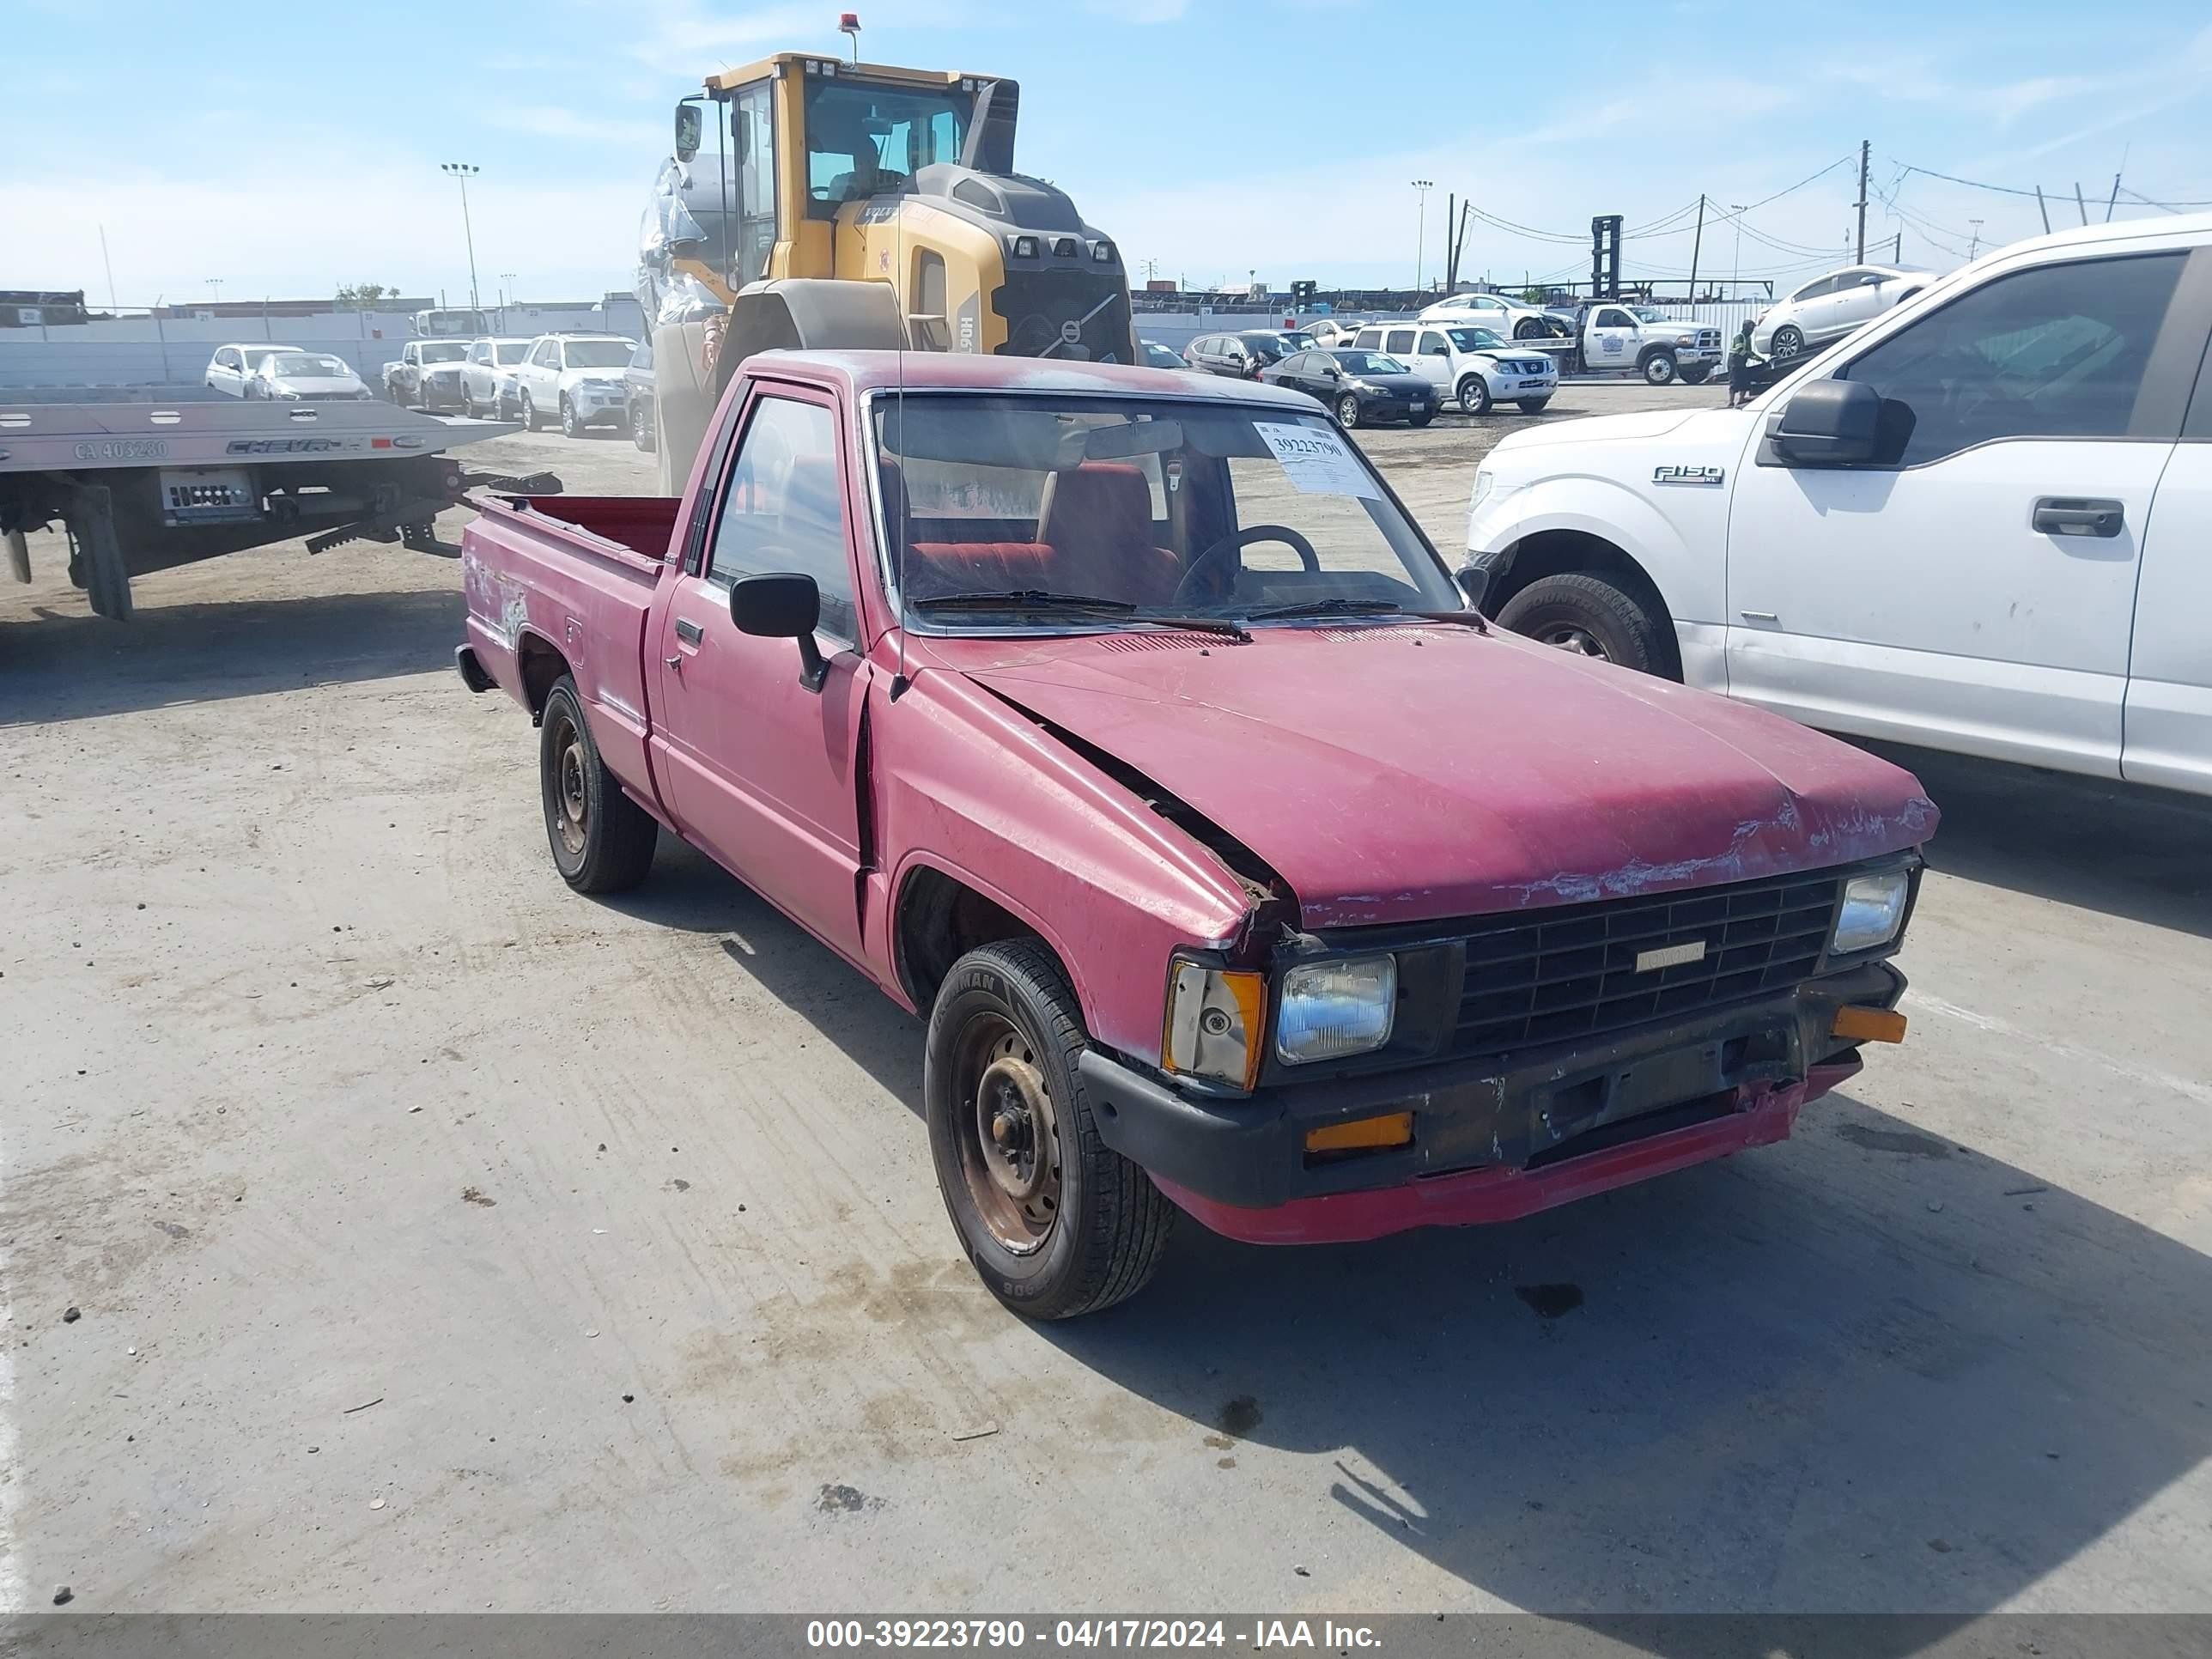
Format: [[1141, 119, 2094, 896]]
[[654, 387, 863, 960]]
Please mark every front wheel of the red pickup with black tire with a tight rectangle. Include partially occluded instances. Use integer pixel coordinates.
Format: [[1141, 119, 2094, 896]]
[[922, 940, 1176, 1318]]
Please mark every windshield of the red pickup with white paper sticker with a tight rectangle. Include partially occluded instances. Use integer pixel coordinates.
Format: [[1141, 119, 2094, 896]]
[[874, 394, 1462, 630]]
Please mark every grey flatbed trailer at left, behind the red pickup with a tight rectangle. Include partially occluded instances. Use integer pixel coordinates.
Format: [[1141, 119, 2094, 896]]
[[0, 392, 560, 622]]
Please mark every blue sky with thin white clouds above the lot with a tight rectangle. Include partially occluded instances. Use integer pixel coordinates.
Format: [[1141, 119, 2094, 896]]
[[0, 0, 2212, 305]]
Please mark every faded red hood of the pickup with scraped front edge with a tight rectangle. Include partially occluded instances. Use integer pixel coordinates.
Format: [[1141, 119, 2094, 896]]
[[915, 623, 1936, 927]]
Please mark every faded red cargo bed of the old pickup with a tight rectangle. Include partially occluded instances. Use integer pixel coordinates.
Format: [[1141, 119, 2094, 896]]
[[460, 495, 681, 814]]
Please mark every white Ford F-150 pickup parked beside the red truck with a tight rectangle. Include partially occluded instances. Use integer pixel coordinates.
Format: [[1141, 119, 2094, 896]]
[[1467, 215, 2212, 794]]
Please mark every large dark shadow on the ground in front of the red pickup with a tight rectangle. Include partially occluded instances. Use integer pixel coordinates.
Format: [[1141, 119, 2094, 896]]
[[1036, 1097, 2212, 1655]]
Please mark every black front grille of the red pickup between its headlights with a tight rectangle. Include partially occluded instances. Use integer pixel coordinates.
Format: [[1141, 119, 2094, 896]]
[[1451, 874, 1840, 1055]]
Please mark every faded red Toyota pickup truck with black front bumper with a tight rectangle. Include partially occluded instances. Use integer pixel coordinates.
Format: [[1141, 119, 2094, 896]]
[[458, 352, 1936, 1318]]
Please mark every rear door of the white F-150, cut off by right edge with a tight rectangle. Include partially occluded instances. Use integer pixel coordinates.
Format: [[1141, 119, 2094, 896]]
[[2119, 313, 2212, 794]]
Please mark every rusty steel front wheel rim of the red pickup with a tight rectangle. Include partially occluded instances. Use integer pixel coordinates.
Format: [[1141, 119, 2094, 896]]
[[953, 1013, 1061, 1256]]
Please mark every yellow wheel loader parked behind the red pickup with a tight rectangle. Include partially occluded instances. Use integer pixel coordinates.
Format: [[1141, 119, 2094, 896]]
[[641, 51, 1123, 493]]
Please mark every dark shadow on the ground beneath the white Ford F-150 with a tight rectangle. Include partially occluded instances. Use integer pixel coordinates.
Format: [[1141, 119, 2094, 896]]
[[1863, 744, 2212, 938]]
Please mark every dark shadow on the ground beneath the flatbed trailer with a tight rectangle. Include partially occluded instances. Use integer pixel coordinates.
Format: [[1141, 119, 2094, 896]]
[[0, 588, 462, 726]]
